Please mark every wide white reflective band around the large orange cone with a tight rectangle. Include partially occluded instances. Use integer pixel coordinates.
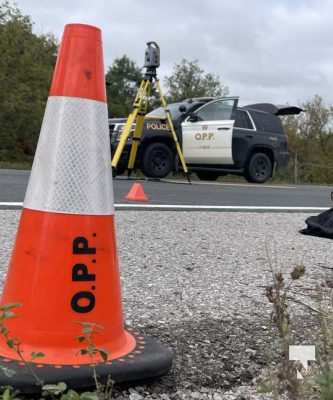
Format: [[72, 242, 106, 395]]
[[23, 97, 114, 215]]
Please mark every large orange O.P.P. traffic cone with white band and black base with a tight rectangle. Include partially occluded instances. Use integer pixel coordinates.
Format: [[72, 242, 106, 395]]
[[0, 24, 172, 391]]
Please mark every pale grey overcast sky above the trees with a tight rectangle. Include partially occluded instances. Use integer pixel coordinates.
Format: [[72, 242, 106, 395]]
[[17, 0, 333, 104]]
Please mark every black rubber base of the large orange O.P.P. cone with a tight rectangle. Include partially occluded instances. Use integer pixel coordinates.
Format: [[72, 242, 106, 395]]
[[0, 332, 173, 394]]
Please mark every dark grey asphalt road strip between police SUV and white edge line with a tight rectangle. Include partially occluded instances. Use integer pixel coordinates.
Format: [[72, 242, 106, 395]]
[[0, 170, 333, 207]]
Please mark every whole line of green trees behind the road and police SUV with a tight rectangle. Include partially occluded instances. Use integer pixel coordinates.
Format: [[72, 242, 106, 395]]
[[0, 1, 333, 183]]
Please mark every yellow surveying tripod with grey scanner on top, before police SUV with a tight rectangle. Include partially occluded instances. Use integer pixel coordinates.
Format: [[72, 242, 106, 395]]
[[112, 42, 189, 180]]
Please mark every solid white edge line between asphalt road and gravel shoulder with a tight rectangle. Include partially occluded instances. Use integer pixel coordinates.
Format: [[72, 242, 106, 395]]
[[0, 202, 329, 212]]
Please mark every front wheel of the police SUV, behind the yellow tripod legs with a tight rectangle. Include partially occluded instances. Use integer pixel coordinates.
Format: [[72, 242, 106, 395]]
[[141, 143, 173, 178]]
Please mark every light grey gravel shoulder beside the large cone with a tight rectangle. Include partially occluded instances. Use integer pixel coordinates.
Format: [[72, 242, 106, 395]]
[[0, 211, 332, 400]]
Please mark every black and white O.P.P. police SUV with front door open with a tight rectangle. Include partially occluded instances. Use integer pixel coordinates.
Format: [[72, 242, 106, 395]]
[[109, 97, 302, 183]]
